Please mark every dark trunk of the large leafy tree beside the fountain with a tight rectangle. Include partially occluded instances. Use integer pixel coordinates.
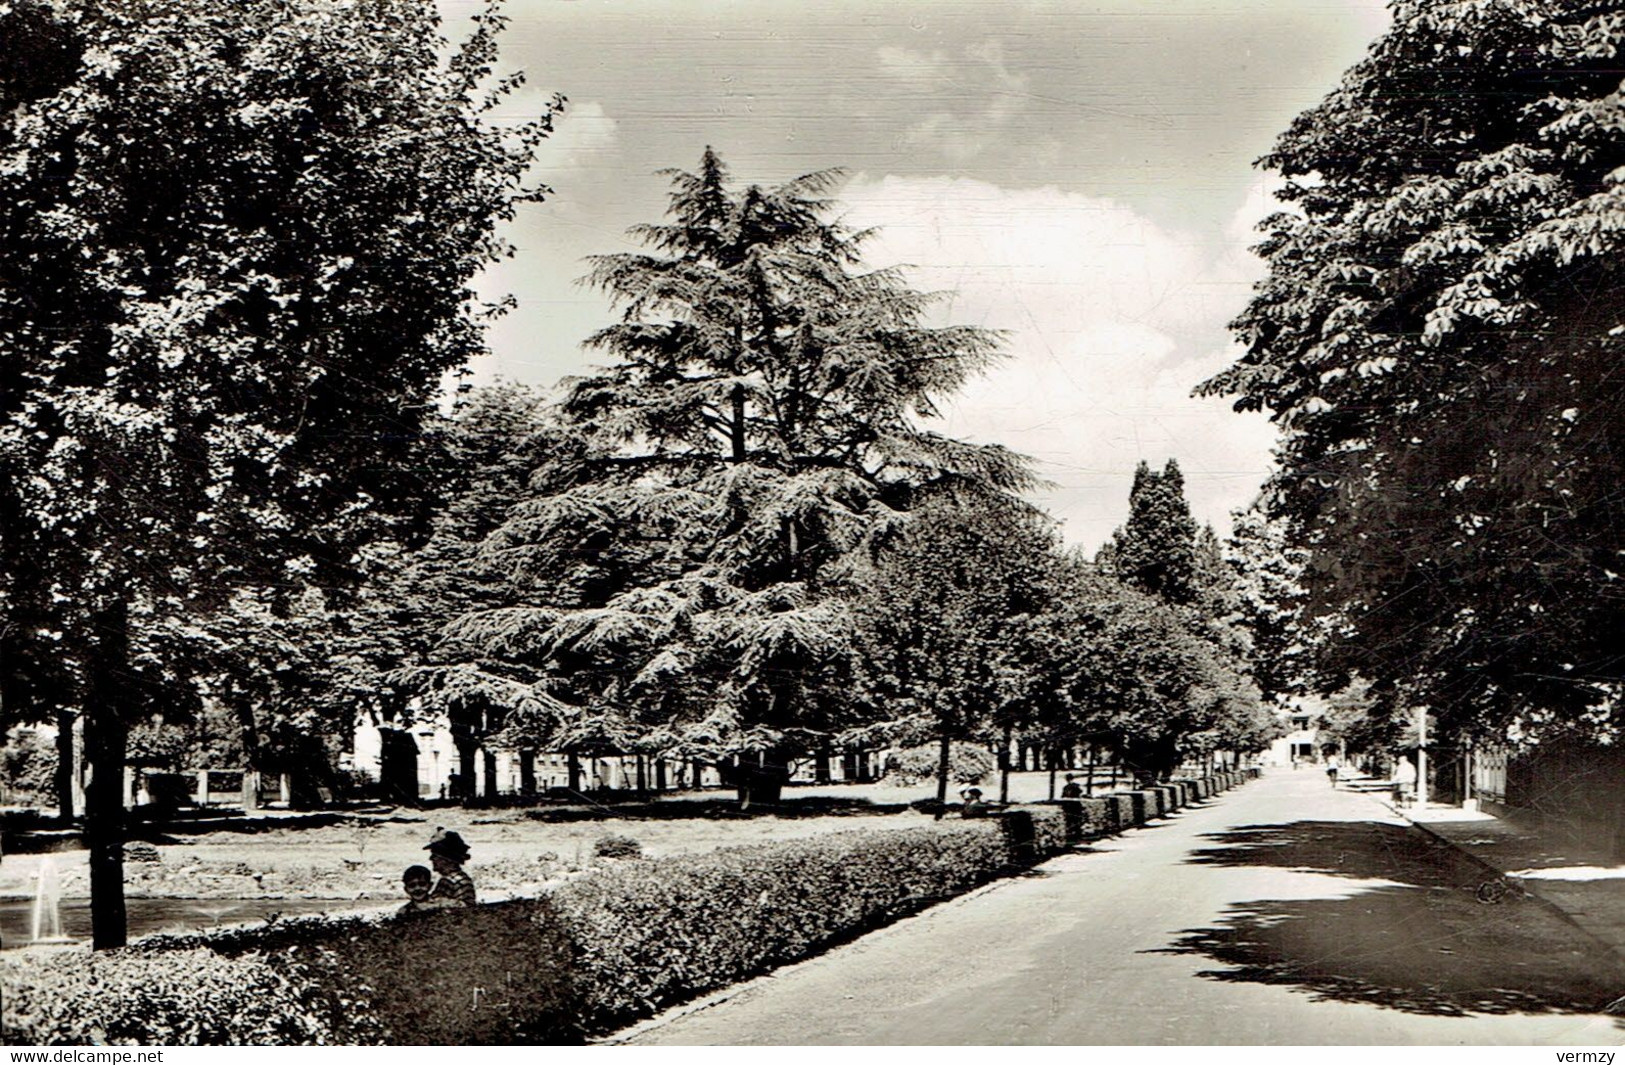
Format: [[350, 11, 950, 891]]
[[85, 602, 130, 950]]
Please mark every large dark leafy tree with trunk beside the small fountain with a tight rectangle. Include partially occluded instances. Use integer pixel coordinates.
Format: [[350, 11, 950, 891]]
[[0, 0, 551, 946]]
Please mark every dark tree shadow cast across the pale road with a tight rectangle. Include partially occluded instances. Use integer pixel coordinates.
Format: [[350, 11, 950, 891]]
[[1155, 821, 1625, 1016]]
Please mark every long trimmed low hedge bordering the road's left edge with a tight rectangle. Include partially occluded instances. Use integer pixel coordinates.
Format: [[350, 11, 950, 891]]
[[0, 774, 1240, 1045]]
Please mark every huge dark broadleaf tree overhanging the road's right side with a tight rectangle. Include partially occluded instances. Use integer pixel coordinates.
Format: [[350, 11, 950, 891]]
[[1203, 0, 1625, 744]]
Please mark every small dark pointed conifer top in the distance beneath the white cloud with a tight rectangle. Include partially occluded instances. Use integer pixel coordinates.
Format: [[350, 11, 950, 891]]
[[1102, 459, 1201, 605]]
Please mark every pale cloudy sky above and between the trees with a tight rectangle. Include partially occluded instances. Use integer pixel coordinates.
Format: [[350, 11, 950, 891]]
[[442, 0, 1386, 550]]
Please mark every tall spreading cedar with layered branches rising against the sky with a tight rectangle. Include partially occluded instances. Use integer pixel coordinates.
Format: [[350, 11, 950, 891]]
[[416, 150, 1025, 800]]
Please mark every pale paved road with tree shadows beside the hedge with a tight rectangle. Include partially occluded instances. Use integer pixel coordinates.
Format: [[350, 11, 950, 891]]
[[624, 769, 1625, 1045]]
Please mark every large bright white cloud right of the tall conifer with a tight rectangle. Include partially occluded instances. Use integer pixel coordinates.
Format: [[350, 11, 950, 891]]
[[843, 177, 1272, 548]]
